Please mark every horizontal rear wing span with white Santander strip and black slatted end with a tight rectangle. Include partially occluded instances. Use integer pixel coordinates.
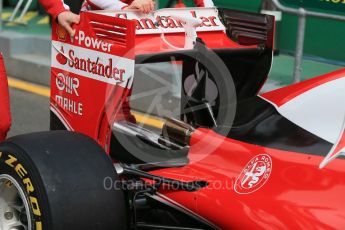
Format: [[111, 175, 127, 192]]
[[93, 7, 274, 56]]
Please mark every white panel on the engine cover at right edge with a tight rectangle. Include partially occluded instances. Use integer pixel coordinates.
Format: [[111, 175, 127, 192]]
[[261, 76, 345, 144]]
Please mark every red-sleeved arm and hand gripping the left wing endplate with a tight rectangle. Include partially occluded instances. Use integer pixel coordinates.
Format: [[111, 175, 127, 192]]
[[39, 0, 80, 37]]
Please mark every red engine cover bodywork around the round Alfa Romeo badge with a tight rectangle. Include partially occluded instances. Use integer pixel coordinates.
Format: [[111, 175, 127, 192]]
[[154, 69, 345, 229]]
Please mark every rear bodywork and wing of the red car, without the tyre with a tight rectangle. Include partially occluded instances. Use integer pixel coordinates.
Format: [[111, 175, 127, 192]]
[[51, 9, 345, 229]]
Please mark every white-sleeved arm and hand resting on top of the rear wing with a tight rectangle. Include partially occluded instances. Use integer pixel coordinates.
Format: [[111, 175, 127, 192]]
[[86, 0, 155, 13]]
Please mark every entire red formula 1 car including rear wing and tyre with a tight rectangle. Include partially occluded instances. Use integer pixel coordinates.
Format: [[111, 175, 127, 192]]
[[0, 8, 345, 230]]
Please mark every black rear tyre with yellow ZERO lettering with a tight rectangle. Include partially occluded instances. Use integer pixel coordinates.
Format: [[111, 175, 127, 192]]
[[0, 131, 127, 230]]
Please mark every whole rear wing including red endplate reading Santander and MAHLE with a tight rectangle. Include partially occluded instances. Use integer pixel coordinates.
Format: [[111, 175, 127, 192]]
[[51, 9, 274, 151]]
